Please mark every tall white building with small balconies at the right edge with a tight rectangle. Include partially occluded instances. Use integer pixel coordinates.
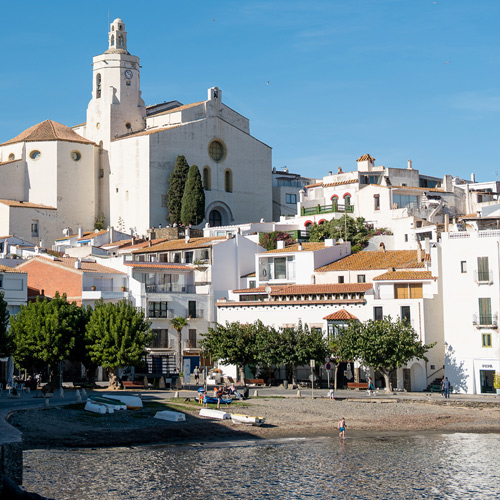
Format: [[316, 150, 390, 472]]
[[438, 230, 500, 394]]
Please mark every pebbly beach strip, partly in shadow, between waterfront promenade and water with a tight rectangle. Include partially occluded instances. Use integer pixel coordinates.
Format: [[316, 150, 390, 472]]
[[8, 395, 500, 449]]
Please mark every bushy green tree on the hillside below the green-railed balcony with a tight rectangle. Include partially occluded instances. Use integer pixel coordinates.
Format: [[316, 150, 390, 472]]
[[309, 214, 373, 253]]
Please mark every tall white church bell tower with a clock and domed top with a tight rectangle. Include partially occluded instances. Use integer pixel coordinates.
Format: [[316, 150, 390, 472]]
[[85, 18, 146, 149]]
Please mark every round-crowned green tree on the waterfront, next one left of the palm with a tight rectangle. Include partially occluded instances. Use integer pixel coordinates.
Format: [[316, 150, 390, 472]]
[[85, 300, 154, 389]]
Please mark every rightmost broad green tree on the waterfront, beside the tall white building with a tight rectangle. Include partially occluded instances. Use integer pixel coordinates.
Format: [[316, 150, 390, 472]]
[[337, 316, 435, 391]]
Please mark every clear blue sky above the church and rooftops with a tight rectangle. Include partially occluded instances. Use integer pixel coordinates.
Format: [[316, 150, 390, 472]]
[[0, 0, 500, 181]]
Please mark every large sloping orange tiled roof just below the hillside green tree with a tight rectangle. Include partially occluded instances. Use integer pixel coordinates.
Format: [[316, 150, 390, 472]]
[[316, 250, 424, 273]]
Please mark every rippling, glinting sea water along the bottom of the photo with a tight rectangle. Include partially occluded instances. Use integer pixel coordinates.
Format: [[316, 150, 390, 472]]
[[24, 434, 500, 500]]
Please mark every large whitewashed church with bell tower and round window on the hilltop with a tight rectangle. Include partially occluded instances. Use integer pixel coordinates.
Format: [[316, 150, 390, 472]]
[[0, 18, 272, 248]]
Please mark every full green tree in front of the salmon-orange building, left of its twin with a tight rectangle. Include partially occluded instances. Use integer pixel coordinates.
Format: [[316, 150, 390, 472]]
[[10, 293, 85, 389]]
